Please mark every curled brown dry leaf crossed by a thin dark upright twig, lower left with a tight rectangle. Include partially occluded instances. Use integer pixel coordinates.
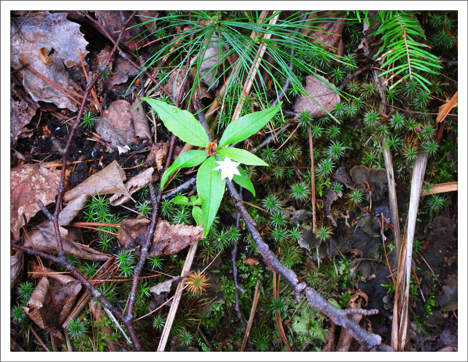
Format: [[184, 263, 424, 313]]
[[23, 220, 109, 261]]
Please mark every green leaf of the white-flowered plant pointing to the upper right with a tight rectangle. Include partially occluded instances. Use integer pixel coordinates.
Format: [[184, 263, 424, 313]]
[[218, 102, 282, 148]]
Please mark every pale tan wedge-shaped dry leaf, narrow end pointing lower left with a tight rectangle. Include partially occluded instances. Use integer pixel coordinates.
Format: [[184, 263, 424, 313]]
[[63, 161, 127, 202]]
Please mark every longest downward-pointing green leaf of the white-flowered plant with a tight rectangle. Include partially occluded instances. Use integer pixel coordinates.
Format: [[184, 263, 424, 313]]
[[197, 156, 226, 237]]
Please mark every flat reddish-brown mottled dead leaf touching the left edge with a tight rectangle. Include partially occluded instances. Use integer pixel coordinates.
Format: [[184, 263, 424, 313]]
[[10, 164, 60, 240]]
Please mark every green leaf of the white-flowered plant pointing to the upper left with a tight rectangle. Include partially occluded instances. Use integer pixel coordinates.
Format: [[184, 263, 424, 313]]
[[143, 97, 209, 147]]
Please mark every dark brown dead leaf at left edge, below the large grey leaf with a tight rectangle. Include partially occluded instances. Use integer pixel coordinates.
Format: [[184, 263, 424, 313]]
[[10, 82, 39, 145]]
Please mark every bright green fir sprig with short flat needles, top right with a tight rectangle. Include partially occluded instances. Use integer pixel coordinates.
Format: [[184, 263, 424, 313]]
[[374, 11, 441, 92]]
